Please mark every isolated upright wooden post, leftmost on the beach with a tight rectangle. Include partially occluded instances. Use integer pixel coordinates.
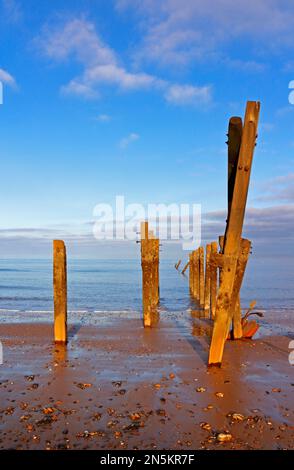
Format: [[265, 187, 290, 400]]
[[53, 240, 67, 344]]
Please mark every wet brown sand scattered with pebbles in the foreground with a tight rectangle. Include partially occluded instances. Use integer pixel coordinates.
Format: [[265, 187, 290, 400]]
[[0, 312, 294, 450]]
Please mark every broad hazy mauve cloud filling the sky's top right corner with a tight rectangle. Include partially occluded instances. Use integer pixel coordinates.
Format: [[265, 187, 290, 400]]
[[116, 0, 294, 69]]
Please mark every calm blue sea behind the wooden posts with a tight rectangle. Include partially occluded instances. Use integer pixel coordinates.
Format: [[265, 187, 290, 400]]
[[0, 256, 294, 322]]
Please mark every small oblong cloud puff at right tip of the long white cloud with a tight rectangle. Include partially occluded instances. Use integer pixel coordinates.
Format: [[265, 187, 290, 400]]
[[165, 85, 211, 105]]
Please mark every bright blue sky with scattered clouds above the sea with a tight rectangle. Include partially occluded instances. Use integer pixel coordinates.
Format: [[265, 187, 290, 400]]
[[0, 0, 294, 257]]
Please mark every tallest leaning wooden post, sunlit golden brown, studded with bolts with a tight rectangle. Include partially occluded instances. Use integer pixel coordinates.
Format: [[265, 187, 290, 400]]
[[208, 101, 260, 365]]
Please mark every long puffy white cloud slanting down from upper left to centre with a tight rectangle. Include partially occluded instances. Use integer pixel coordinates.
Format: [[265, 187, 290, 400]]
[[38, 19, 210, 104]]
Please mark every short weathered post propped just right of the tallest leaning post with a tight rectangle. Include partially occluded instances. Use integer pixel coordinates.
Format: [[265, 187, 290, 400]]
[[230, 238, 251, 339]]
